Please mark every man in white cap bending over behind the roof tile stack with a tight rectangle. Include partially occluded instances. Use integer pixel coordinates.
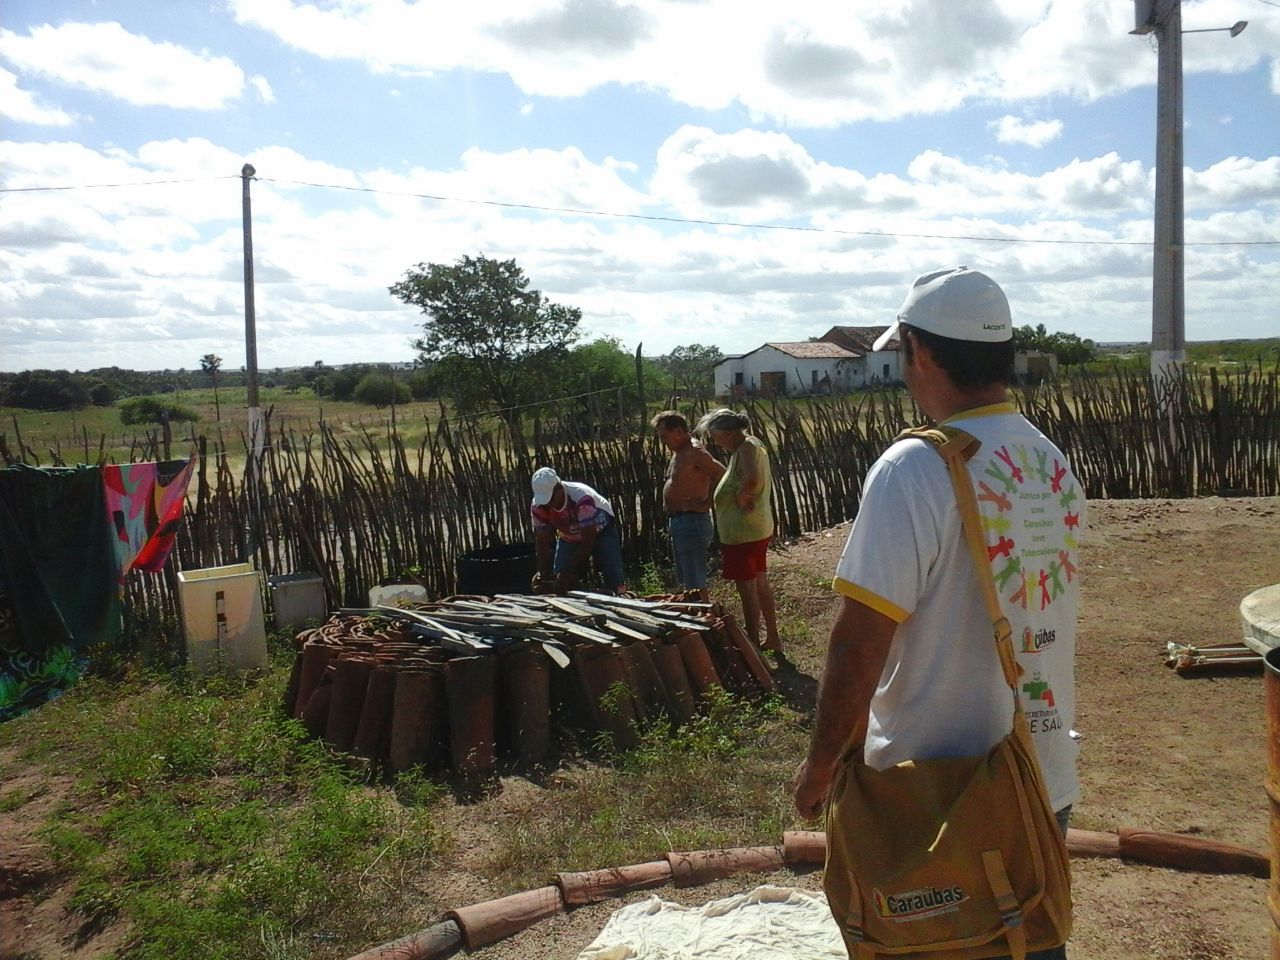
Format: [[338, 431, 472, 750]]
[[529, 467, 627, 594]]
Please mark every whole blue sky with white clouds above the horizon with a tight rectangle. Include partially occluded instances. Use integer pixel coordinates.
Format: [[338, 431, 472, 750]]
[[0, 0, 1280, 371]]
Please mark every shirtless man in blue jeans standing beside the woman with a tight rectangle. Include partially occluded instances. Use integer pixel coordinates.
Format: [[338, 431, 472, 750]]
[[653, 410, 724, 603]]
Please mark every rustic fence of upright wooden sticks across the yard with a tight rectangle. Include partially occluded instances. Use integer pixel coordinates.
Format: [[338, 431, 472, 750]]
[[0, 367, 1280, 632]]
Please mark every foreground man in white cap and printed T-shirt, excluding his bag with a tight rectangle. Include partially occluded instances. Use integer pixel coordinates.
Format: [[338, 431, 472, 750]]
[[794, 266, 1084, 960]]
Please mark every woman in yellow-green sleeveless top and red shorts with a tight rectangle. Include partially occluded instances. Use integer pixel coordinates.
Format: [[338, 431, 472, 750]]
[[698, 407, 782, 653]]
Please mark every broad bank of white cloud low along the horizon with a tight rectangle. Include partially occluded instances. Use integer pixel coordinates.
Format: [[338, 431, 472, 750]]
[[0, 127, 1280, 369]]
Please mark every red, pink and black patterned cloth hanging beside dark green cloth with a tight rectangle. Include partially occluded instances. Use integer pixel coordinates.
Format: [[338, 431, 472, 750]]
[[102, 457, 196, 580]]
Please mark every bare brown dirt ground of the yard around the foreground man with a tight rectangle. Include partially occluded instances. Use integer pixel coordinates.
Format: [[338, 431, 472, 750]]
[[0, 498, 1280, 960]]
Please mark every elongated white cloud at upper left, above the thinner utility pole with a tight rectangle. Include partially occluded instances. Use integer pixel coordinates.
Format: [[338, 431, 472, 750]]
[[0, 23, 244, 110]]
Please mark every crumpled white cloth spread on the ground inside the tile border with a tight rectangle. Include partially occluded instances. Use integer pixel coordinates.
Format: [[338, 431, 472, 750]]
[[577, 886, 849, 960]]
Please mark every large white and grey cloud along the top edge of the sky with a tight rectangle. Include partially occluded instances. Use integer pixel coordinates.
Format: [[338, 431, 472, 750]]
[[232, 0, 1280, 129]]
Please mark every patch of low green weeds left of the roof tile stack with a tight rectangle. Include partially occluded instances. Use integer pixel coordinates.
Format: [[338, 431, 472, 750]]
[[0, 668, 445, 960]]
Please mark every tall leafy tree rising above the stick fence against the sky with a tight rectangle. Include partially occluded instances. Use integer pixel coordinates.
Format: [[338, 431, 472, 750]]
[[389, 253, 582, 424]]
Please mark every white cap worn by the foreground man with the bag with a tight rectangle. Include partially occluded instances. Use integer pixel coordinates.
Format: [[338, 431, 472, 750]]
[[872, 266, 1014, 349]]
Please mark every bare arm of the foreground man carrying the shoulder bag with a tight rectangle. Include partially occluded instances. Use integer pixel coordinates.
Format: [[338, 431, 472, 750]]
[[794, 596, 897, 819]]
